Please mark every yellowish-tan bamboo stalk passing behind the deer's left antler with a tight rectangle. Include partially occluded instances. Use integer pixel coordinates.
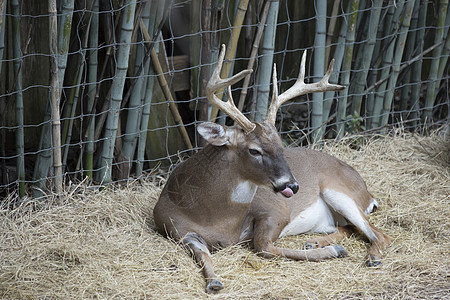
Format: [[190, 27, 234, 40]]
[[209, 0, 249, 121]]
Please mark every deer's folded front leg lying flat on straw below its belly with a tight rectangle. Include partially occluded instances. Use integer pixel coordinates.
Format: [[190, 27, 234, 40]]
[[253, 216, 347, 261]]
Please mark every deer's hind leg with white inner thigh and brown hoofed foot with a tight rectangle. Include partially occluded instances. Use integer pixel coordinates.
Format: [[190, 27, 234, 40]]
[[323, 190, 390, 267]]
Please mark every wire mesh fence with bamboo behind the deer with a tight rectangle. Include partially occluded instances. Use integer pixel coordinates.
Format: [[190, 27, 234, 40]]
[[0, 0, 450, 197]]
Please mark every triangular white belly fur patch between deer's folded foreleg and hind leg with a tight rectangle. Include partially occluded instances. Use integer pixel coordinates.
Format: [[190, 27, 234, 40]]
[[280, 197, 336, 237]]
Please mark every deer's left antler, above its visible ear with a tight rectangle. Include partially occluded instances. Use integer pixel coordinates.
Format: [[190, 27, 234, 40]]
[[206, 45, 256, 133]]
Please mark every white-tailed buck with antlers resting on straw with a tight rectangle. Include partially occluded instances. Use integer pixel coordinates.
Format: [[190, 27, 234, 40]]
[[153, 46, 390, 293]]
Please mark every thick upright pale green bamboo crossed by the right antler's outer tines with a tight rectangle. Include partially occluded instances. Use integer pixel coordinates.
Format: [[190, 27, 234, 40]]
[[311, 0, 327, 143]]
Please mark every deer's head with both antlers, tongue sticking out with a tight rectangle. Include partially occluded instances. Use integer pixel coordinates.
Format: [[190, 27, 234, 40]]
[[197, 45, 343, 197]]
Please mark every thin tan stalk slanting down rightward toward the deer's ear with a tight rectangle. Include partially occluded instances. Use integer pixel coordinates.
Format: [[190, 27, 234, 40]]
[[141, 20, 193, 149]]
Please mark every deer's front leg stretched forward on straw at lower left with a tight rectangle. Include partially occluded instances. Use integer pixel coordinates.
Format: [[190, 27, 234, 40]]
[[182, 232, 223, 293]]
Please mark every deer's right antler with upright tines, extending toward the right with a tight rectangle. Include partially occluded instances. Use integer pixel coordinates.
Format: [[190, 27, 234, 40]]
[[266, 50, 345, 125]]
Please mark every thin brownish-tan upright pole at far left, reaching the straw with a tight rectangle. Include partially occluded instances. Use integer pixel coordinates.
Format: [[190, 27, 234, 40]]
[[48, 0, 63, 195]]
